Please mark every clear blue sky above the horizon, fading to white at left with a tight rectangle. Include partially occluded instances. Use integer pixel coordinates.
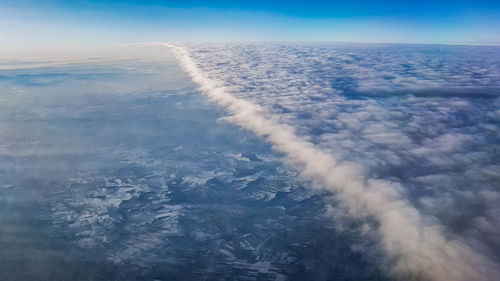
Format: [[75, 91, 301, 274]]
[[0, 0, 500, 57]]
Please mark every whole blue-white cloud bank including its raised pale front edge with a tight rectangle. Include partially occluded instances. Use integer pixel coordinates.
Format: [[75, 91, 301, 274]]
[[164, 44, 500, 280]]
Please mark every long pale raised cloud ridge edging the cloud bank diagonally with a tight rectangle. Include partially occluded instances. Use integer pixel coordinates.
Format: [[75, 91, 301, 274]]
[[160, 44, 500, 281]]
